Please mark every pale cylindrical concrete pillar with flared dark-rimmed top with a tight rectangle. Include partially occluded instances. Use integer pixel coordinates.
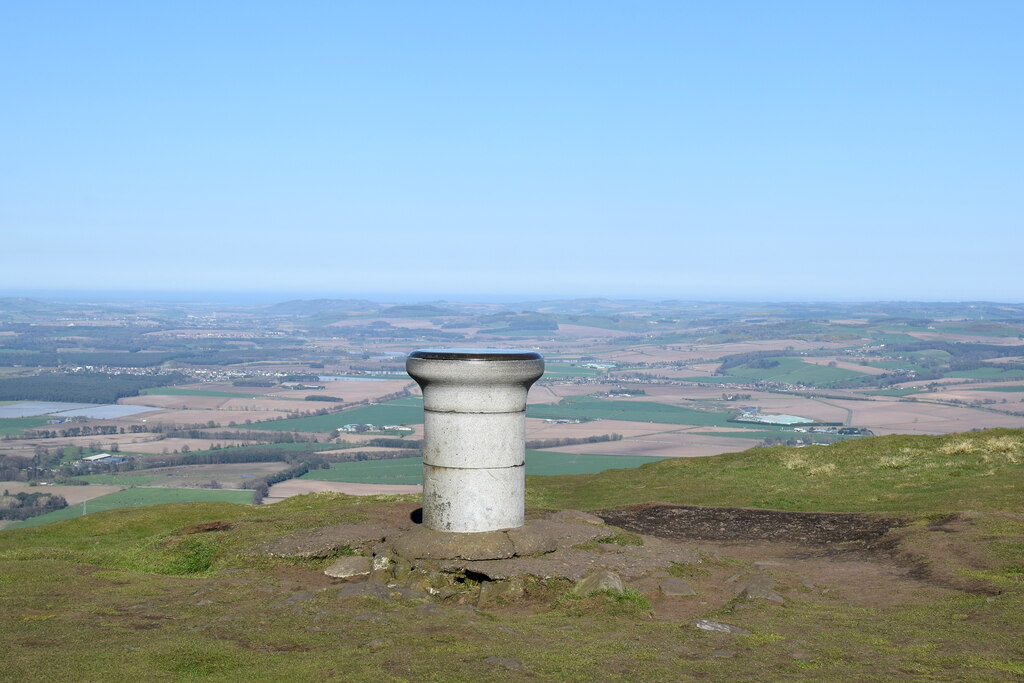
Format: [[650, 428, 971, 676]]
[[406, 349, 544, 533]]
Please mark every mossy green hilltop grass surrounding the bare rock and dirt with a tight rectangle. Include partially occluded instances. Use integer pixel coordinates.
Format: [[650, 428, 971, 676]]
[[0, 430, 1024, 681]]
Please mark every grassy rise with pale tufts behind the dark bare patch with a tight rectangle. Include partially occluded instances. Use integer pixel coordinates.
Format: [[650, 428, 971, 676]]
[[530, 429, 1024, 513]]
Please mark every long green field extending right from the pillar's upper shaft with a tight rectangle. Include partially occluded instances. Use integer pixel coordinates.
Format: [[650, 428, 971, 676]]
[[526, 396, 753, 427]]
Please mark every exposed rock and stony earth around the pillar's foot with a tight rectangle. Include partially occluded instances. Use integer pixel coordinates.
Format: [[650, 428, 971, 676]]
[[259, 510, 781, 608]]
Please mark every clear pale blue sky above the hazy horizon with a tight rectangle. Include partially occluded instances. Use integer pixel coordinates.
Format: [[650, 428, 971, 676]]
[[0, 0, 1024, 301]]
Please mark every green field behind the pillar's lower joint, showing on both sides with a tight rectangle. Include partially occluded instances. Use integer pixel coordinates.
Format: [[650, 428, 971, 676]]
[[300, 451, 662, 484]]
